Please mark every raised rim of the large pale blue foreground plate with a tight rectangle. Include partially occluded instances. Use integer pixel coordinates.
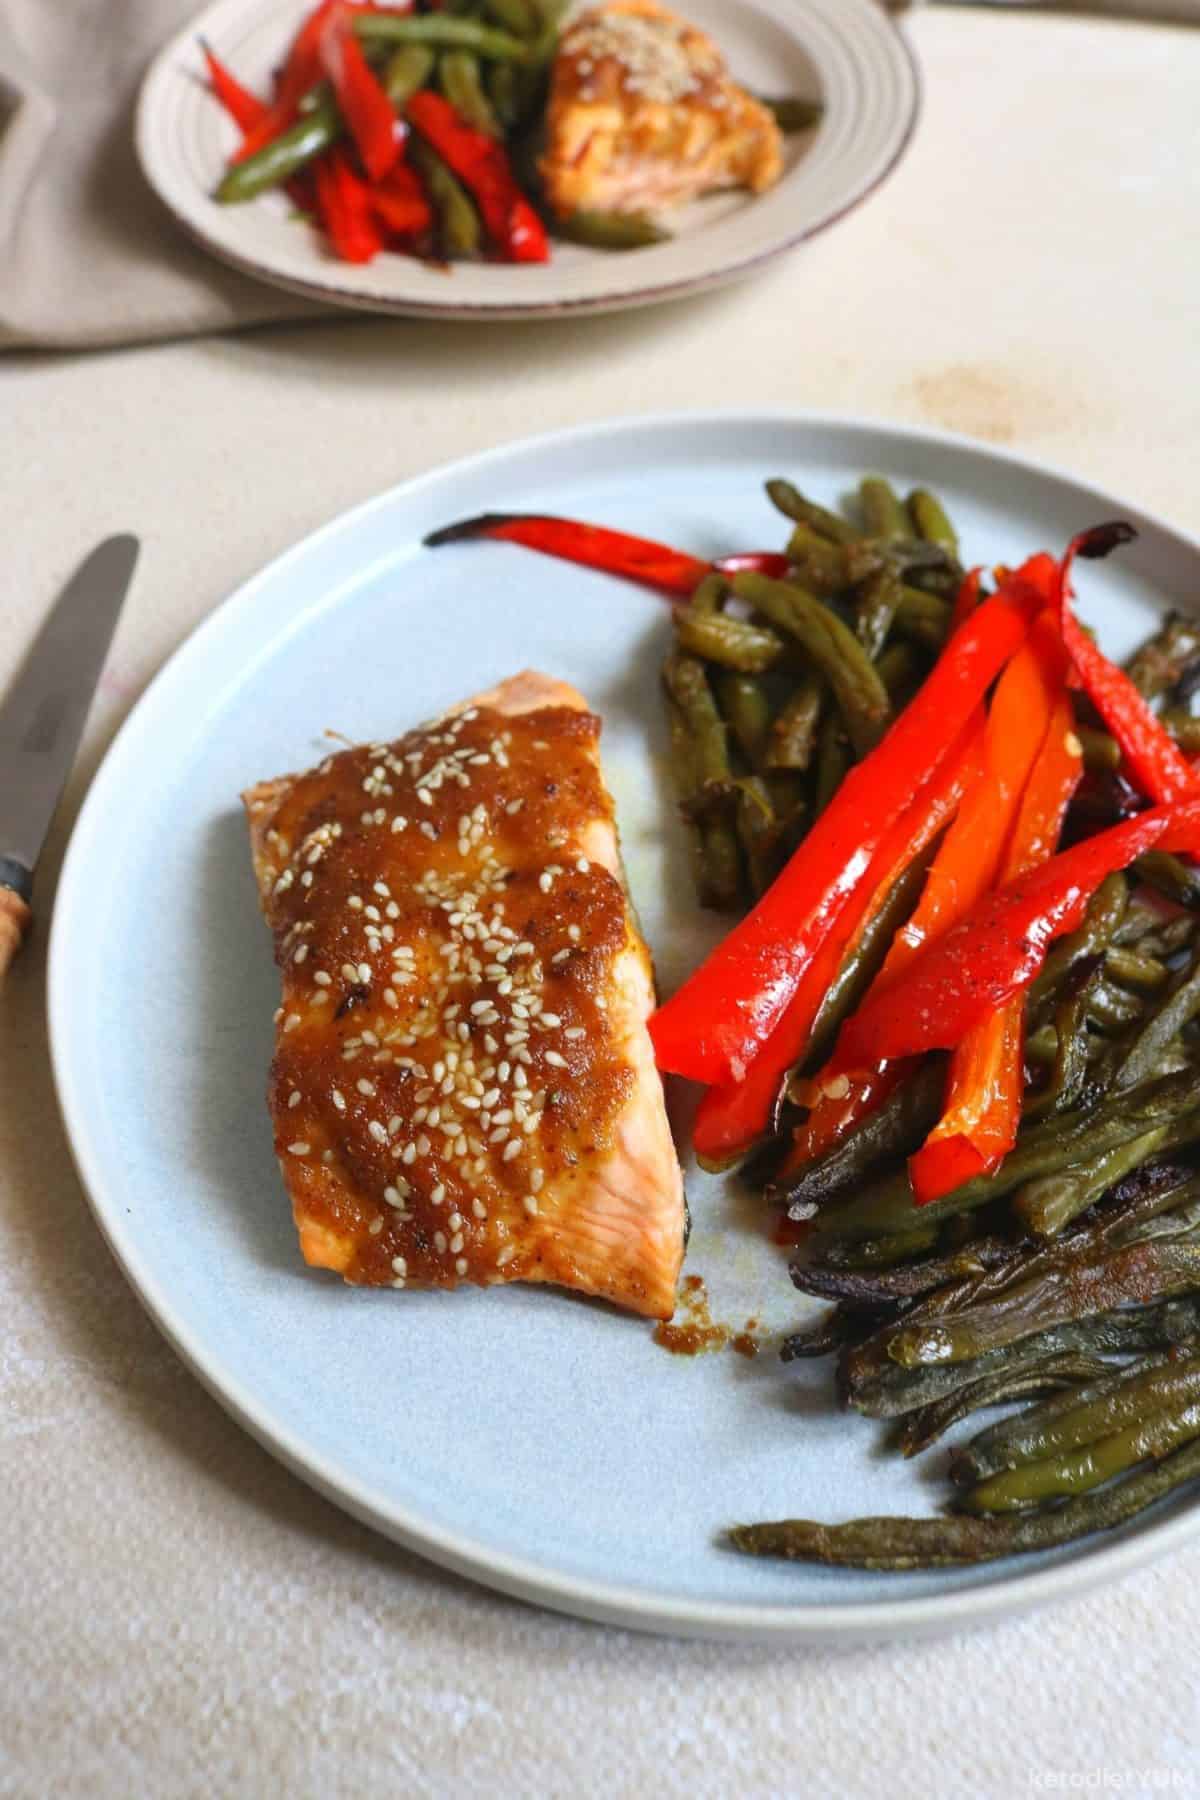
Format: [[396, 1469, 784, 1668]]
[[47, 409, 1200, 1643]]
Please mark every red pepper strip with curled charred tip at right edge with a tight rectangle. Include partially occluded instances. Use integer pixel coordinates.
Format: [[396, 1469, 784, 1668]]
[[1056, 520, 1200, 805]]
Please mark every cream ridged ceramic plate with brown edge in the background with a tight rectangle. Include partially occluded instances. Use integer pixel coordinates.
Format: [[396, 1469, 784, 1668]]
[[137, 0, 919, 319]]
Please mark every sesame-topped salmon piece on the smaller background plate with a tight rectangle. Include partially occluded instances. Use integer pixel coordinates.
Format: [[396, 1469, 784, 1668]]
[[538, 0, 783, 218]]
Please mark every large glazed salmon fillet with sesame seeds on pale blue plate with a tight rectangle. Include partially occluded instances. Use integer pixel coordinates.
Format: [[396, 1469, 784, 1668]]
[[243, 673, 685, 1318]]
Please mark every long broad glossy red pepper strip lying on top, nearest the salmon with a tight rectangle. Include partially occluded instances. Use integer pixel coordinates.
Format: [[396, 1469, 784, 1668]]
[[649, 578, 1040, 1082]]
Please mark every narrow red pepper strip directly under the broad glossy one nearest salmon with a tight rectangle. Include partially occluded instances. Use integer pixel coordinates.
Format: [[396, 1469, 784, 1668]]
[[693, 716, 982, 1166]]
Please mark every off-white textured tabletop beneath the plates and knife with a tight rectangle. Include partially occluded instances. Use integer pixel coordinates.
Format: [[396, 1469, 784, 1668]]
[[0, 9, 1200, 1796]]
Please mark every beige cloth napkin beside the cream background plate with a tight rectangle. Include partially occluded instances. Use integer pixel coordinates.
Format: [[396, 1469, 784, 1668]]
[[0, 0, 1200, 349]]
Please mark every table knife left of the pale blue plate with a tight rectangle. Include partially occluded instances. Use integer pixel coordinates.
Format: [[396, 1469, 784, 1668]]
[[0, 533, 139, 979]]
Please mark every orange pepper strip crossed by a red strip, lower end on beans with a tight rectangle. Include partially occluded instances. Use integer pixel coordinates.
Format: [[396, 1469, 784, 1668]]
[[909, 640, 1083, 1206]]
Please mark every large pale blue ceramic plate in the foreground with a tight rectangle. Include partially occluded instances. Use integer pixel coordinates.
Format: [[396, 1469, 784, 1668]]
[[50, 416, 1200, 1638]]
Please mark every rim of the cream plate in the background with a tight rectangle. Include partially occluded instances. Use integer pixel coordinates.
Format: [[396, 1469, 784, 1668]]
[[133, 0, 925, 324]]
